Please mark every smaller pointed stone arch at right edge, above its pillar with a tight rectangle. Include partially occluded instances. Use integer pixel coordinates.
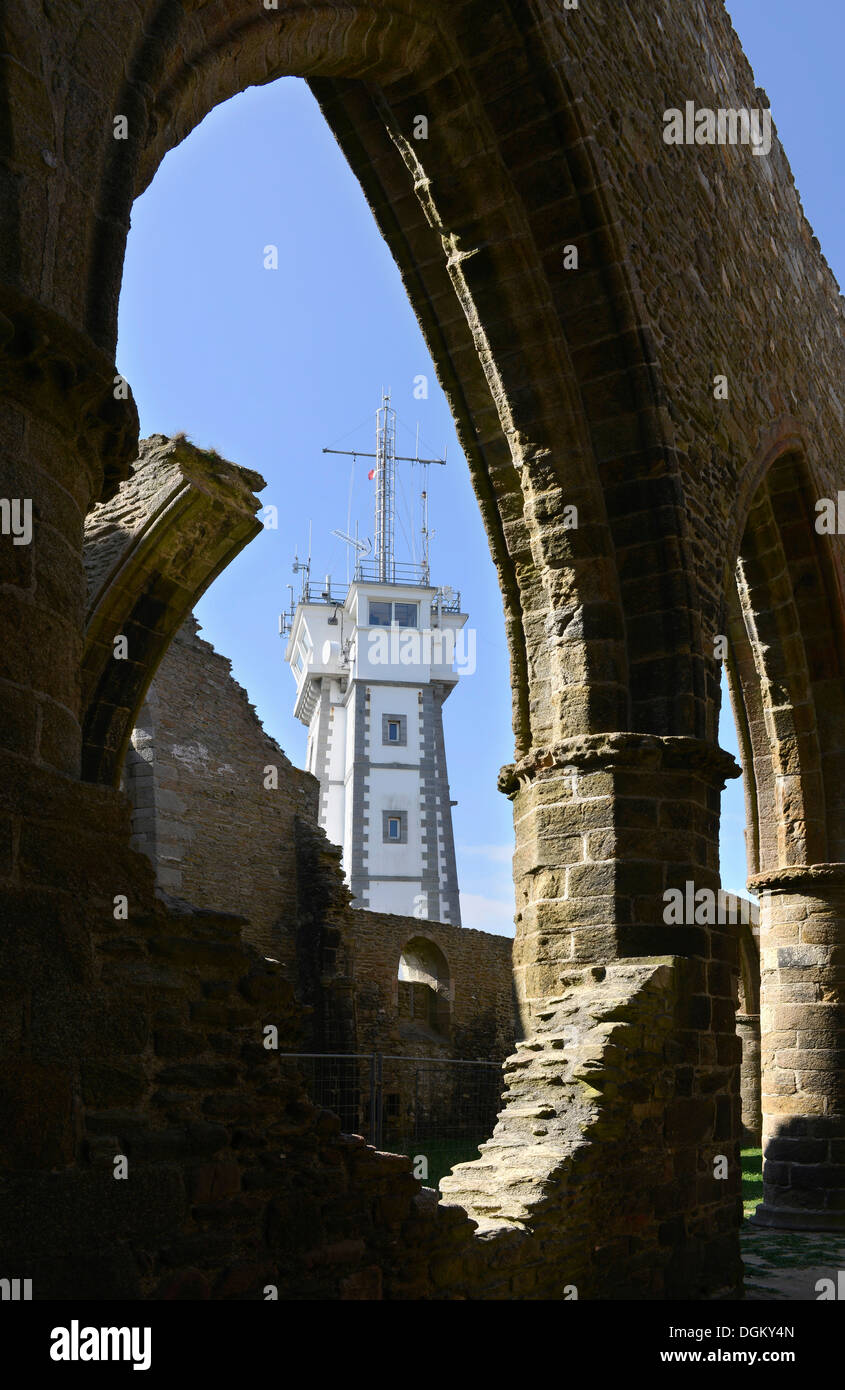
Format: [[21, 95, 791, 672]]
[[728, 442, 845, 876]]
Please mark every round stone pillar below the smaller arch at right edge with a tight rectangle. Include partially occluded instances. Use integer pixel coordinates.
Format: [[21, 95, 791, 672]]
[[752, 865, 845, 1230]]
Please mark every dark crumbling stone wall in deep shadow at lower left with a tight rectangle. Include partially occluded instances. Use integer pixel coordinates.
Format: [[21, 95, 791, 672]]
[[0, 753, 489, 1300]]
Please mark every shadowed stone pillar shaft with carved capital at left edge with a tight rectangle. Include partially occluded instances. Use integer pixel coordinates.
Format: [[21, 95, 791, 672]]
[[0, 286, 138, 776]]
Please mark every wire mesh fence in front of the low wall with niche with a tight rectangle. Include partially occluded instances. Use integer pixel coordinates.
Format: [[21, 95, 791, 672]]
[[279, 1052, 502, 1187]]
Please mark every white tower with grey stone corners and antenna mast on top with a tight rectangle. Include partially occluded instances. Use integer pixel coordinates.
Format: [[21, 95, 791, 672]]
[[282, 395, 474, 926]]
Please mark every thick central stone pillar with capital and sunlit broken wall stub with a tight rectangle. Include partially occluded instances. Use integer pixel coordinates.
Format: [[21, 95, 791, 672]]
[[442, 734, 741, 1298]]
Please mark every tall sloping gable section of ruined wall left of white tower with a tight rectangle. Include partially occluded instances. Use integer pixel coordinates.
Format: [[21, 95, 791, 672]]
[[126, 617, 318, 965]]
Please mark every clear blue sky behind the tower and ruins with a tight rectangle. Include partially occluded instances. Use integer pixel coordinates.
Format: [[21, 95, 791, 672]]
[[118, 0, 845, 933]]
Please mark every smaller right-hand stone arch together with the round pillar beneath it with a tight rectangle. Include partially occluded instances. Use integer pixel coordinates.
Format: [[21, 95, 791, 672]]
[[728, 421, 845, 1229]]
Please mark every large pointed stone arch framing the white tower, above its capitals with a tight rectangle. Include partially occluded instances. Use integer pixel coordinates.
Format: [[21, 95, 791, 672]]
[[79, 0, 712, 755]]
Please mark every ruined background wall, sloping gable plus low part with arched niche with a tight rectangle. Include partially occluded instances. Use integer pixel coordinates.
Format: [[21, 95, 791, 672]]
[[124, 617, 514, 1062]]
